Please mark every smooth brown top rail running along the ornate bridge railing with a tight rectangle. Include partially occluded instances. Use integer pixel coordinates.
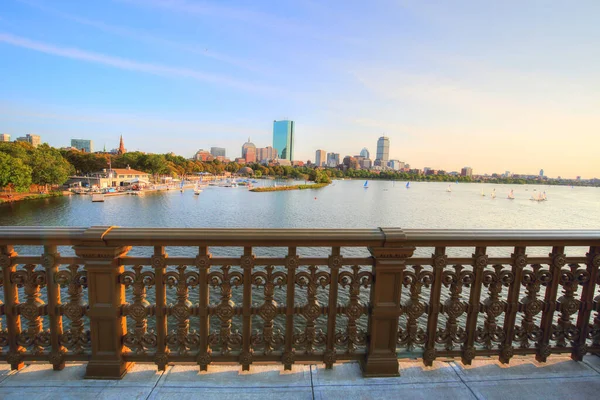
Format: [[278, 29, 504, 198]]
[[0, 226, 600, 247]]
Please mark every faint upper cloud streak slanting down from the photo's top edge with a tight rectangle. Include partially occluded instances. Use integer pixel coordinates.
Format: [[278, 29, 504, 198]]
[[17, 0, 270, 74]]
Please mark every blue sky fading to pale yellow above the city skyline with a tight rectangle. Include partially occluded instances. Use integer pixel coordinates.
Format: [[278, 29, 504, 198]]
[[0, 0, 600, 178]]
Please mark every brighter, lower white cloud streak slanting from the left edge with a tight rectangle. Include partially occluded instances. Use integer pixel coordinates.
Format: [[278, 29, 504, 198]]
[[0, 33, 275, 94]]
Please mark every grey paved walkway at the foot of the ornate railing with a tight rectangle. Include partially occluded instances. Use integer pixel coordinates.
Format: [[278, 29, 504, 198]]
[[0, 356, 600, 400]]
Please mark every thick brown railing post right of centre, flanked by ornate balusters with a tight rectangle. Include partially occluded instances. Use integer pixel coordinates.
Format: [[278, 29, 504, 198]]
[[361, 229, 415, 377]]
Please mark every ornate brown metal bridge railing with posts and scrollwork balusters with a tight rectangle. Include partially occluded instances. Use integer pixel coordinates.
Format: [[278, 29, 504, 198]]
[[0, 227, 600, 378]]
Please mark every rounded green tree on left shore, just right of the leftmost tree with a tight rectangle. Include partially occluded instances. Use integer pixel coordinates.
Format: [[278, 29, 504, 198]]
[[30, 143, 74, 186]]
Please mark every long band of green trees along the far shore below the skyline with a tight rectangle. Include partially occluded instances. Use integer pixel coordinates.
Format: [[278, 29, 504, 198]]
[[0, 142, 600, 200]]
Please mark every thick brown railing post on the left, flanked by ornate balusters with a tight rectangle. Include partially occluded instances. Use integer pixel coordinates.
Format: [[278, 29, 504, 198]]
[[74, 227, 133, 379]]
